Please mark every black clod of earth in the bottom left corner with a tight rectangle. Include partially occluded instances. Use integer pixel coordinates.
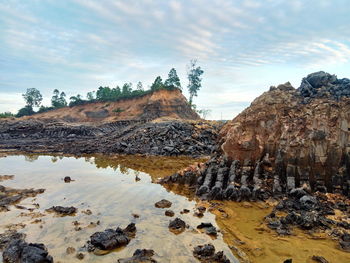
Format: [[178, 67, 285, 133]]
[[2, 239, 53, 263]]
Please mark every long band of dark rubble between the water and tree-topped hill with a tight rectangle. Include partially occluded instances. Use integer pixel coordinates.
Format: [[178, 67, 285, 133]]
[[0, 119, 221, 157]]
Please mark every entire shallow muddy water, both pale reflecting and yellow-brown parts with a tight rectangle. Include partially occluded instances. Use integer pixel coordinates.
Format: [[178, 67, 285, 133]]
[[0, 155, 350, 263]]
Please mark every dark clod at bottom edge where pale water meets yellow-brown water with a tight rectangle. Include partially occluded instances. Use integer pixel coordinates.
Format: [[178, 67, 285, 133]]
[[193, 244, 230, 263]]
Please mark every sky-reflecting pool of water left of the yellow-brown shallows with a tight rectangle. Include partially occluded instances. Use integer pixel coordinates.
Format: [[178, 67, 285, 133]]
[[0, 155, 236, 262]]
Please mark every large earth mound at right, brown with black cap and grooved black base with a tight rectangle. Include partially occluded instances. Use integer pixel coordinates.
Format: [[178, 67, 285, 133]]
[[164, 72, 350, 200]]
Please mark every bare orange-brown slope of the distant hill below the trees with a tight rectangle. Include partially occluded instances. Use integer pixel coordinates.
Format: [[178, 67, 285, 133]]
[[22, 89, 200, 123]]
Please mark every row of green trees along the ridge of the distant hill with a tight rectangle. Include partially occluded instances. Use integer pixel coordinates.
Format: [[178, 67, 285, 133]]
[[11, 60, 203, 117]]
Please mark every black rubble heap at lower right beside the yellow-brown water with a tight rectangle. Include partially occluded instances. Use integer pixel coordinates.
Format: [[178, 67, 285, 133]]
[[265, 188, 350, 252]]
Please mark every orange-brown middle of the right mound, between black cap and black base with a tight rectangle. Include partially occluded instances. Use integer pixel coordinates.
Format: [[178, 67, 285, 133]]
[[220, 83, 350, 195]]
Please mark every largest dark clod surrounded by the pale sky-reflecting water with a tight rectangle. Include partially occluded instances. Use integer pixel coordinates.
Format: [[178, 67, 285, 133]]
[[88, 223, 136, 251]]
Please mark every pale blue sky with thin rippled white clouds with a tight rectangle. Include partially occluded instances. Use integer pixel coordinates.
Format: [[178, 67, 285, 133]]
[[0, 0, 350, 119]]
